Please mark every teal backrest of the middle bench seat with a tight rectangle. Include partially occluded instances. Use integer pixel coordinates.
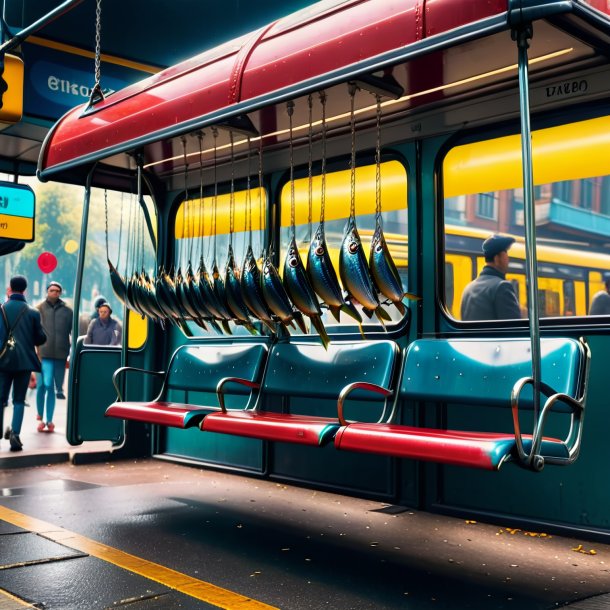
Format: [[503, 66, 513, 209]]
[[262, 341, 399, 401]]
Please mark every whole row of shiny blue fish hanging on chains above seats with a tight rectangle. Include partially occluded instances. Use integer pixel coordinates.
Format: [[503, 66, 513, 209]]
[[108, 92, 417, 347]]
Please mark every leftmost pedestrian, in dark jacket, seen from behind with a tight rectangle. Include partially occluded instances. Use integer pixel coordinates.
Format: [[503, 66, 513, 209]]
[[0, 275, 47, 451]]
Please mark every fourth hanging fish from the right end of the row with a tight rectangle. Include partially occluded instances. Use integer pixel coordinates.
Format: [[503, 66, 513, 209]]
[[284, 235, 330, 348]]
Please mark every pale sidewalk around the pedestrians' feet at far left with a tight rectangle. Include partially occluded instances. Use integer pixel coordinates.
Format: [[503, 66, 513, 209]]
[[0, 390, 112, 468]]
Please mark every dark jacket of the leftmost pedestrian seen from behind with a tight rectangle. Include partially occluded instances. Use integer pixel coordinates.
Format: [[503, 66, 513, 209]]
[[0, 294, 47, 372]]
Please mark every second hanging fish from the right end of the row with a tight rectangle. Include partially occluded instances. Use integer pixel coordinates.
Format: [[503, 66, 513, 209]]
[[339, 216, 390, 324]]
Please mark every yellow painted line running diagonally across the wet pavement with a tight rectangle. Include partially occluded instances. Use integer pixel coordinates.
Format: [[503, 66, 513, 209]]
[[0, 506, 275, 610]]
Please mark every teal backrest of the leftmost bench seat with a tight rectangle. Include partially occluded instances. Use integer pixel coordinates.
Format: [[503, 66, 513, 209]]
[[164, 343, 268, 395]]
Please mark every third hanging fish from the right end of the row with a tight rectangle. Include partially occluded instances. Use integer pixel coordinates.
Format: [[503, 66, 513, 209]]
[[307, 222, 362, 324]]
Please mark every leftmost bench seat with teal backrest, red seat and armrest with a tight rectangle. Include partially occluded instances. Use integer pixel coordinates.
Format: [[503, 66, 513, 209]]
[[106, 343, 268, 428]]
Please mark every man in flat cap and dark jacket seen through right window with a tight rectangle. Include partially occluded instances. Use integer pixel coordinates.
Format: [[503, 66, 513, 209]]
[[461, 234, 521, 321]]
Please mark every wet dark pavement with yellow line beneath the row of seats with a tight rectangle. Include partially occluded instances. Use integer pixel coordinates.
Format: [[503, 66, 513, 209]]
[[0, 459, 610, 610]]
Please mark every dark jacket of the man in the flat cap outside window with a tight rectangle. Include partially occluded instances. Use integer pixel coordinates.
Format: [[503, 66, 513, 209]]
[[462, 265, 521, 320]]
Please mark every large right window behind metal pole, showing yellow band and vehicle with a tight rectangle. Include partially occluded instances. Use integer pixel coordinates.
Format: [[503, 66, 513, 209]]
[[443, 117, 610, 320]]
